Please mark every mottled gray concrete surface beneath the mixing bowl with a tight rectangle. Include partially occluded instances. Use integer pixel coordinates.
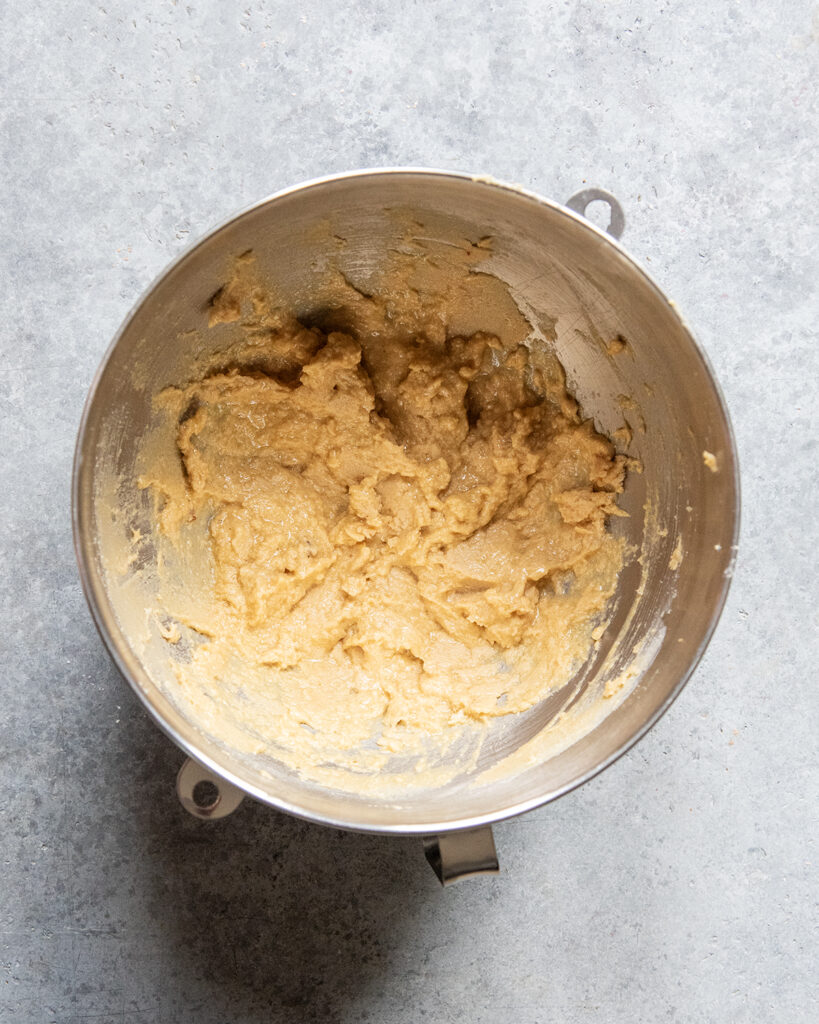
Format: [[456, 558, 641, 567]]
[[0, 0, 819, 1024]]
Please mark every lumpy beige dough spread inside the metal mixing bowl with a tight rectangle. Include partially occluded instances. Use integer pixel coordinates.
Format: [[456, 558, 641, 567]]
[[142, 237, 626, 775]]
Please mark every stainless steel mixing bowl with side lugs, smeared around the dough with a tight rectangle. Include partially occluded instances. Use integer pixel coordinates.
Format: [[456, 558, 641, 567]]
[[73, 169, 739, 880]]
